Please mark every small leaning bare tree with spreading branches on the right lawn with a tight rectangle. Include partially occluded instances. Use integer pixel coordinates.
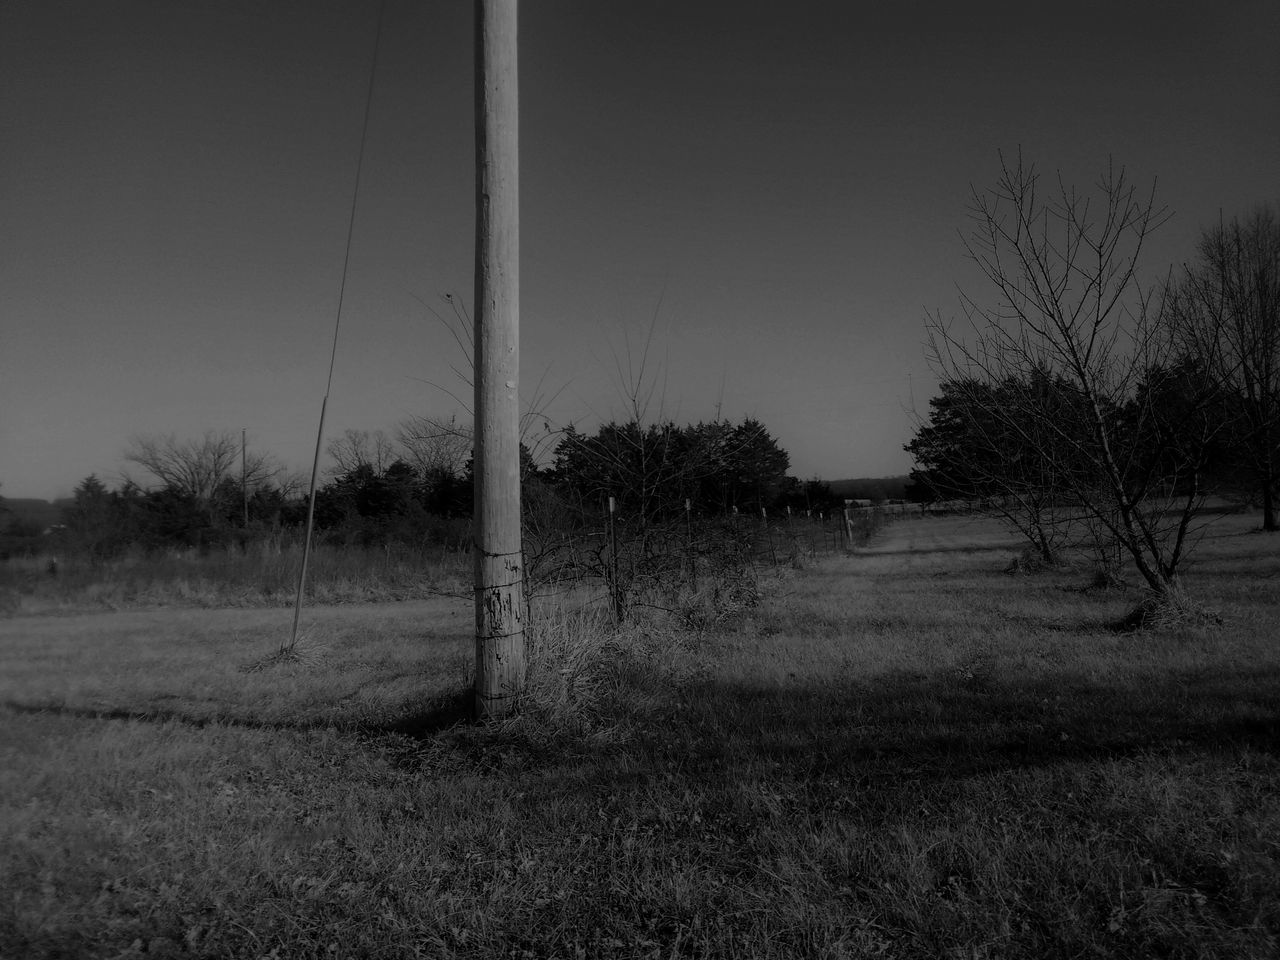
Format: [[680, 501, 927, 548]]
[[928, 155, 1219, 608]]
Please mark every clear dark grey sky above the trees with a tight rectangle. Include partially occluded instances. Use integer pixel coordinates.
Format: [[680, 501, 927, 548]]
[[0, 0, 1280, 498]]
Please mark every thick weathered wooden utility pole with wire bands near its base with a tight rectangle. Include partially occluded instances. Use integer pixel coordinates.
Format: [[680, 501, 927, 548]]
[[474, 0, 525, 719]]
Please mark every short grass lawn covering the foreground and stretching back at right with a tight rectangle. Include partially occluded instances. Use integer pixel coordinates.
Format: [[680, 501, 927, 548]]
[[0, 516, 1280, 960]]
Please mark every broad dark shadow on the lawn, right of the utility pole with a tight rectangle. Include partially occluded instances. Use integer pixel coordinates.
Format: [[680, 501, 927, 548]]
[[699, 669, 1280, 778]]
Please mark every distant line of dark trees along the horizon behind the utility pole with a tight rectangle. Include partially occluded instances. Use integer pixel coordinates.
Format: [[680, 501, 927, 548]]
[[0, 419, 906, 559]]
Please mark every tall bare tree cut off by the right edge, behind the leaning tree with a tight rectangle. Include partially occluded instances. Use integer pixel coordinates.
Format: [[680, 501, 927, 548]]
[[1170, 206, 1280, 531]]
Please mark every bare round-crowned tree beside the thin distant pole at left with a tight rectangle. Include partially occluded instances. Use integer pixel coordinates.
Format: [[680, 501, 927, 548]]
[[124, 430, 283, 509]]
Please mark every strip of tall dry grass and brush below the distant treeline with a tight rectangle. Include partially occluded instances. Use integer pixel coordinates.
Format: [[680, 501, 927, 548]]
[[0, 511, 884, 622]]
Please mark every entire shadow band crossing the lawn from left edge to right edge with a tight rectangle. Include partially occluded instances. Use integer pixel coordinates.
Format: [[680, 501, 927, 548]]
[[0, 666, 1280, 781]]
